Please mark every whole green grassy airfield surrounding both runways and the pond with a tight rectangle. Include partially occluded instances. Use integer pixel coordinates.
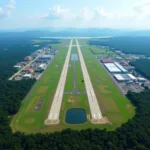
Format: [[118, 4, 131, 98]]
[[10, 39, 135, 133]]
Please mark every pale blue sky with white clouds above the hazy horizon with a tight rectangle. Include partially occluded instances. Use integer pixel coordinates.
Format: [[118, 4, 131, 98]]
[[0, 0, 150, 30]]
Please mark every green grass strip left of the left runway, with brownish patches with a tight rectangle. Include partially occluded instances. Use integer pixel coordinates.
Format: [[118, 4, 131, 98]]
[[11, 42, 67, 132]]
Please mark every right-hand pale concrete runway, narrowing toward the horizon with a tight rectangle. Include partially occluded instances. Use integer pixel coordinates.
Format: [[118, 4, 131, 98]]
[[76, 40, 105, 123]]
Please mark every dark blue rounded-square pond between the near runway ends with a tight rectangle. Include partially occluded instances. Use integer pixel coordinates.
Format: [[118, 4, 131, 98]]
[[66, 108, 86, 124]]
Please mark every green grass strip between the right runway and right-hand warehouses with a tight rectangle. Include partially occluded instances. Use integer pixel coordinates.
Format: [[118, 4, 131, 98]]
[[82, 44, 135, 127]]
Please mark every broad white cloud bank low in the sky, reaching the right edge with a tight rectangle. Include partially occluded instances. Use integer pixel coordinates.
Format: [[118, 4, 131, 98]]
[[25, 0, 150, 28]]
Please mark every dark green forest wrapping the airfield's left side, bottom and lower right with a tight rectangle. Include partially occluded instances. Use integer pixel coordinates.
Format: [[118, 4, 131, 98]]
[[0, 34, 150, 150]]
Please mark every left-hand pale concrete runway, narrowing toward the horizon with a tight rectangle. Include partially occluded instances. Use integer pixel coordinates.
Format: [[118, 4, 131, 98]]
[[45, 40, 72, 125]]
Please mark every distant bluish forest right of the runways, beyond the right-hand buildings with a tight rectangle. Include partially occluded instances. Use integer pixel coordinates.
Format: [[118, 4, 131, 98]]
[[89, 37, 150, 56]]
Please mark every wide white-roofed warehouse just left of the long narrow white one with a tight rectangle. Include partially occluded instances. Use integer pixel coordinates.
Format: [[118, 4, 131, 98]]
[[104, 63, 121, 73]]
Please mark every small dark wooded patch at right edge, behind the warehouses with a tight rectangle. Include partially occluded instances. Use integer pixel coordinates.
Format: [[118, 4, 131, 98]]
[[130, 59, 150, 79]]
